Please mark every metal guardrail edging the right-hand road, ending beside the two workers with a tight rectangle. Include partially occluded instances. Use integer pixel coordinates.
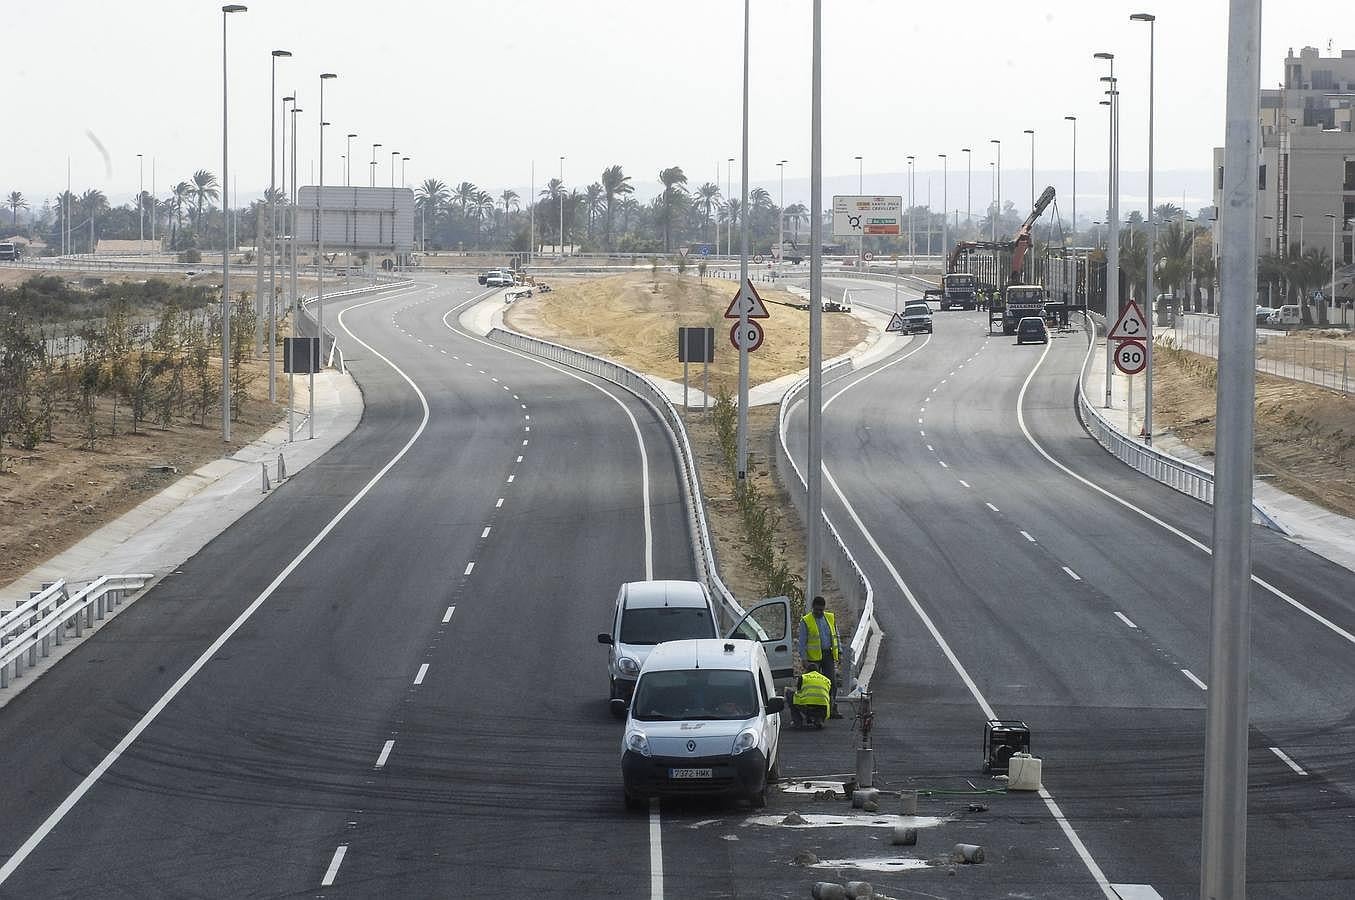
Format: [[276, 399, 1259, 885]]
[[776, 356, 883, 682]]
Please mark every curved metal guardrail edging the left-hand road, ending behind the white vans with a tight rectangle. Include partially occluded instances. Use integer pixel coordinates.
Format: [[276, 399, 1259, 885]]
[[486, 328, 745, 626]]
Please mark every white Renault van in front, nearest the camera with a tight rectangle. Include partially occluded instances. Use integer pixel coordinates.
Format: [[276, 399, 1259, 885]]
[[611, 637, 789, 809]]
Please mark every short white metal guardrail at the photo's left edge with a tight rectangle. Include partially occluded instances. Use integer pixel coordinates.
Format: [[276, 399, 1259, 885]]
[[0, 575, 154, 687]]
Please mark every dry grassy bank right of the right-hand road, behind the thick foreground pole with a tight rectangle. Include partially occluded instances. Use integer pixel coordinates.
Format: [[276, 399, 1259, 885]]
[[1153, 350, 1355, 516]]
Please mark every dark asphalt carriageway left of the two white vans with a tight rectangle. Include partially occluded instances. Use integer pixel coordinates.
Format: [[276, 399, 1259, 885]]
[[0, 279, 692, 896]]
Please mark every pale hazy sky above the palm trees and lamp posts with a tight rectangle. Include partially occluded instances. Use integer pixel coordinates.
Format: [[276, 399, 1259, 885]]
[[10, 0, 1355, 214]]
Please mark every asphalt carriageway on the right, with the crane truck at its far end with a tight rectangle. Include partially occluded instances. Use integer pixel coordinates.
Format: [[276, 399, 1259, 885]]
[[791, 298, 1355, 897]]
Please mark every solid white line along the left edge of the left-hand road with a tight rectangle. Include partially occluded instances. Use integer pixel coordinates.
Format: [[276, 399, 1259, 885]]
[[0, 287, 430, 885]]
